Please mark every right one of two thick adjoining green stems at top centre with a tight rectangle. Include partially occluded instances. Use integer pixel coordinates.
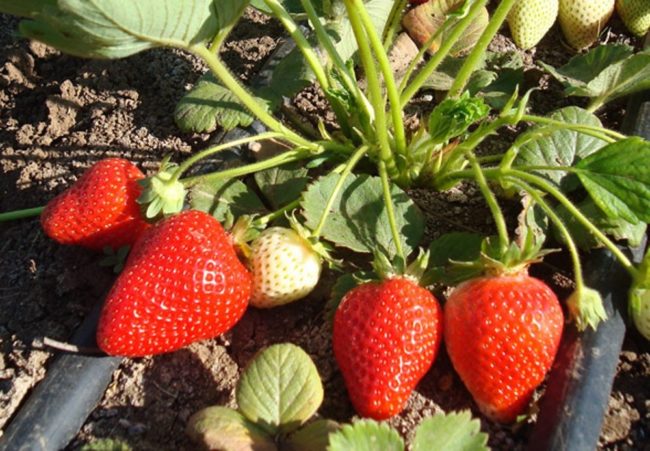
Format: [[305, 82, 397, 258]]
[[357, 1, 406, 154]]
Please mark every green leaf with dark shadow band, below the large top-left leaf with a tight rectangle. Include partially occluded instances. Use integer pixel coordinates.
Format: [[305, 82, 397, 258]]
[[174, 73, 262, 133]]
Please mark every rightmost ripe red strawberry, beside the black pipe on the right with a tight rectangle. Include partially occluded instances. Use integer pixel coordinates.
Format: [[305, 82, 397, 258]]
[[445, 274, 564, 423]]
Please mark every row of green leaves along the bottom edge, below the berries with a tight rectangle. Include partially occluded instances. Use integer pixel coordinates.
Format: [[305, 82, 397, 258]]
[[187, 343, 487, 451]]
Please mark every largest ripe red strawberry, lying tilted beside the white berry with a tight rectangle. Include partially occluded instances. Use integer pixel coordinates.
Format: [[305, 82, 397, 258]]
[[97, 210, 251, 357]]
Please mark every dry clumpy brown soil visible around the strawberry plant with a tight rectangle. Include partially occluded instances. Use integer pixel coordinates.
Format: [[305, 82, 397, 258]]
[[0, 7, 650, 450]]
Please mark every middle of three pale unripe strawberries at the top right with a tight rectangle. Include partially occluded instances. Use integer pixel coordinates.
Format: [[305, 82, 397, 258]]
[[558, 0, 616, 50]]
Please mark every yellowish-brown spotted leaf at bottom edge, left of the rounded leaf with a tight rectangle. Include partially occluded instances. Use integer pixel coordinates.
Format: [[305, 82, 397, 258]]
[[186, 406, 277, 451]]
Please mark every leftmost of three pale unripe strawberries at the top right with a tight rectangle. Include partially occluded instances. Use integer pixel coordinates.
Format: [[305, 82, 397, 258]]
[[508, 0, 559, 50]]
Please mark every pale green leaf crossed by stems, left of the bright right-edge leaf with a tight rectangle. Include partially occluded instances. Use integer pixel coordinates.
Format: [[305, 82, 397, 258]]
[[513, 107, 607, 192]]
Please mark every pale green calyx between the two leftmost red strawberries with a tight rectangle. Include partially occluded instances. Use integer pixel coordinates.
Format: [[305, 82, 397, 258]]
[[138, 157, 187, 221]]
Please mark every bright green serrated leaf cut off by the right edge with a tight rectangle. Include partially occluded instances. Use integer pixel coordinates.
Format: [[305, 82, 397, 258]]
[[576, 137, 650, 224]]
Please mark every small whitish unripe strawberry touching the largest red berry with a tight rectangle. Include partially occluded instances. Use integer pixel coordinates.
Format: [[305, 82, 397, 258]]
[[250, 227, 322, 308]]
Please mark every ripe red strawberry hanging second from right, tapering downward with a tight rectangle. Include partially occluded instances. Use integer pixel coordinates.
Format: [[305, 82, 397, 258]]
[[333, 277, 442, 420]]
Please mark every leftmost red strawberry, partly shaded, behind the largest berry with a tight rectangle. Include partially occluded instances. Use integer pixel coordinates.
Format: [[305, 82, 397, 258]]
[[41, 158, 148, 250]]
